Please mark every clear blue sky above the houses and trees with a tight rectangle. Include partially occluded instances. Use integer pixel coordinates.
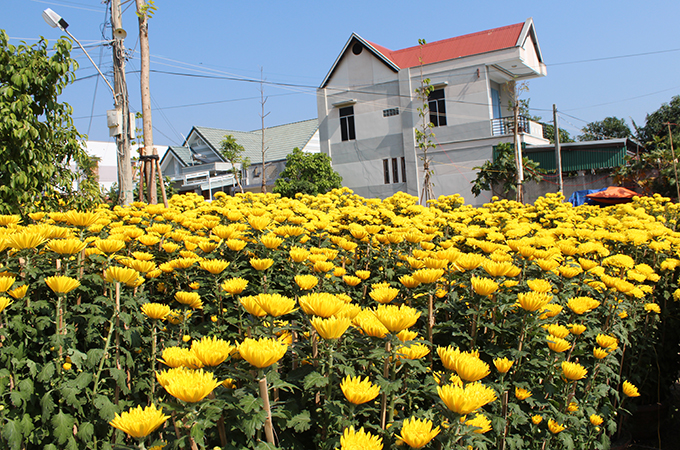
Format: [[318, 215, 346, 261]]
[[5, 0, 680, 150]]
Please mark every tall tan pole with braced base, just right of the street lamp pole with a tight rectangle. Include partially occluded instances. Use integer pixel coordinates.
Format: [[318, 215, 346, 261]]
[[136, 0, 158, 204]]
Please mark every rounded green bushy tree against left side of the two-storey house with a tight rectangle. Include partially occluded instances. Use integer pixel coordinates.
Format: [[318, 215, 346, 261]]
[[274, 147, 342, 198]]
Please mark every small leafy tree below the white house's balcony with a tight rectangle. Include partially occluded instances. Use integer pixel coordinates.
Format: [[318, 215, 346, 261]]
[[471, 143, 545, 198]]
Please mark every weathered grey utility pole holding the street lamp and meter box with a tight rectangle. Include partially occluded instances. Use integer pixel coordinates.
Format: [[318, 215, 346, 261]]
[[111, 0, 133, 205]]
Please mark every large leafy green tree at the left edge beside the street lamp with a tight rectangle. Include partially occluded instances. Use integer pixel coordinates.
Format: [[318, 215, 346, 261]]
[[0, 30, 101, 214]]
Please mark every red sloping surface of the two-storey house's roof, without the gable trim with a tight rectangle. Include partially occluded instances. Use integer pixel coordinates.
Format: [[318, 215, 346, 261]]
[[371, 22, 524, 69]]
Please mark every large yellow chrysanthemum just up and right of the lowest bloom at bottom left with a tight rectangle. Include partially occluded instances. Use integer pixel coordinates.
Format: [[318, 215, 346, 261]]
[[156, 367, 222, 403]]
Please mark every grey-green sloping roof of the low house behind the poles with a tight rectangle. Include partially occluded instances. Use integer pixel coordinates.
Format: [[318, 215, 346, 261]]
[[194, 119, 319, 164]]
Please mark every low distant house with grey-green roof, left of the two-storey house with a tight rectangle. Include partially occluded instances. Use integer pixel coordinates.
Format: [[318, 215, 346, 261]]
[[161, 119, 320, 199]]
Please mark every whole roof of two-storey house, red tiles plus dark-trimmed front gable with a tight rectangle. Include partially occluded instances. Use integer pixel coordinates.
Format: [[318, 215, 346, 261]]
[[321, 18, 543, 88]]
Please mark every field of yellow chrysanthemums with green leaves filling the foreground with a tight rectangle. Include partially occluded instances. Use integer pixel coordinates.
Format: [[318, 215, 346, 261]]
[[0, 189, 680, 450]]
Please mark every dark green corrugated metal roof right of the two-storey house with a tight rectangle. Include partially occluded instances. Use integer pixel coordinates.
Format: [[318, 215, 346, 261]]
[[524, 139, 635, 172]]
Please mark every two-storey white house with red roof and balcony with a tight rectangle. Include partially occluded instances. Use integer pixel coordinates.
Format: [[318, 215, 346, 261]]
[[317, 19, 548, 204]]
